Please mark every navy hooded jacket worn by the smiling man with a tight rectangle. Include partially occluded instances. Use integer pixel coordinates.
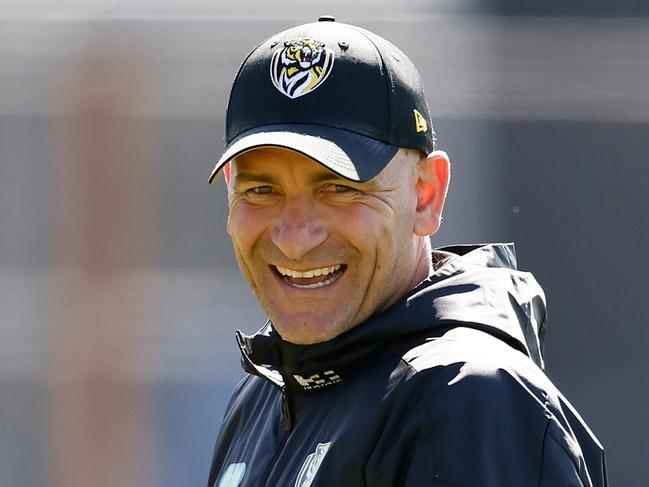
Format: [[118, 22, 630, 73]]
[[208, 244, 607, 487]]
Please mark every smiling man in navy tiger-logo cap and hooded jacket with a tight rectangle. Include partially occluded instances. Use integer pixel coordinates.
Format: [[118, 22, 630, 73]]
[[208, 17, 607, 487]]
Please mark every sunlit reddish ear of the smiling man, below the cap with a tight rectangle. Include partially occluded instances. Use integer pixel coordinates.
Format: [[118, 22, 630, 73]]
[[414, 150, 451, 237]]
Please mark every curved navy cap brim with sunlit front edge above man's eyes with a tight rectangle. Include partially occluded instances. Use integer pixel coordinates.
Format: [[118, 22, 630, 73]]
[[209, 124, 399, 183]]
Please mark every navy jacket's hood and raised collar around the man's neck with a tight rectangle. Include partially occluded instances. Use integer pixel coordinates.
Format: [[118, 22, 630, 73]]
[[237, 243, 546, 390]]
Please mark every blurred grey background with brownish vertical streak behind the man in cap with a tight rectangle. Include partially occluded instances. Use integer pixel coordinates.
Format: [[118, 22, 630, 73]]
[[0, 0, 649, 487]]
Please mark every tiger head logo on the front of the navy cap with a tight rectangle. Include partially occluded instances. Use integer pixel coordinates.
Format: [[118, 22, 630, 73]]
[[270, 38, 334, 98]]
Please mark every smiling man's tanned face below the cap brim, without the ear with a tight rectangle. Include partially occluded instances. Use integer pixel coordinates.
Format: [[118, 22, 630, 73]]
[[228, 148, 425, 344]]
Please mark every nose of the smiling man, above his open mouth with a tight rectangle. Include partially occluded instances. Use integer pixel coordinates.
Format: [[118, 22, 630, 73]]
[[271, 197, 329, 260]]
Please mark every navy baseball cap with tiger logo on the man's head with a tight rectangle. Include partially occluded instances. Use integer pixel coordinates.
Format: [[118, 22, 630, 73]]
[[209, 16, 435, 183]]
